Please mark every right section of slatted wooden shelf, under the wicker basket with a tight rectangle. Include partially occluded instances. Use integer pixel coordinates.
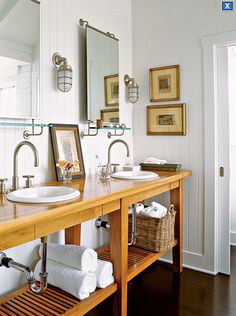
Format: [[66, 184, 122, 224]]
[[97, 239, 178, 281]]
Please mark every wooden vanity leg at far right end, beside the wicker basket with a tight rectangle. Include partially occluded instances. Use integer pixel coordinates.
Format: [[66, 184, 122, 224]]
[[170, 180, 183, 273]]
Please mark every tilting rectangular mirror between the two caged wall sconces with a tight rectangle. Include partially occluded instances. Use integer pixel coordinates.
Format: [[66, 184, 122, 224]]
[[86, 25, 119, 123]]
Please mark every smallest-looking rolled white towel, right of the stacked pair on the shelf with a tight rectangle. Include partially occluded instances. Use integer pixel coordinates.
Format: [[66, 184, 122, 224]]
[[94, 259, 114, 289]]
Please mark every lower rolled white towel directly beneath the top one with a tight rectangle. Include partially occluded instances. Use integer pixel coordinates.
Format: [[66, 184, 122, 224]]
[[34, 260, 97, 300]]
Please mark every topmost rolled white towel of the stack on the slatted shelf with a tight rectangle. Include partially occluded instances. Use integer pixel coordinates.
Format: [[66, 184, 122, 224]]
[[39, 243, 97, 272]]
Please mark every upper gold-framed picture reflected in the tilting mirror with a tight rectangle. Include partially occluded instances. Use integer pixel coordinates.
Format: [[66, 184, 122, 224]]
[[104, 74, 119, 106]]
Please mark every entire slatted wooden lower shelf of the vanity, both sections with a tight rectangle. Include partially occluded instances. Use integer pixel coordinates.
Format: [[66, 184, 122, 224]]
[[0, 240, 178, 316]]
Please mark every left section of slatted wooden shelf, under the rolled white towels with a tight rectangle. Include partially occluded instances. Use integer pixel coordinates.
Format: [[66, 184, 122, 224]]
[[0, 283, 117, 316]]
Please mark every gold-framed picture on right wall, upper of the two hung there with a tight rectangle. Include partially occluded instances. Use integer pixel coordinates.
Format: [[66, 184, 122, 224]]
[[149, 65, 180, 102]]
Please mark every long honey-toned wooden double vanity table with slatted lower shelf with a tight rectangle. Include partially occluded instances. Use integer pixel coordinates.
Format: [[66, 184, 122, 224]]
[[0, 171, 191, 316]]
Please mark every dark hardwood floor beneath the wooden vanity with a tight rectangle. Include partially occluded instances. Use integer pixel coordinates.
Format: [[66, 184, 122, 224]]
[[87, 247, 236, 316]]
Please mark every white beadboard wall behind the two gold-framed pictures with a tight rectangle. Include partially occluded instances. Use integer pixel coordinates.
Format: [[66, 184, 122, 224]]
[[132, 0, 236, 271]]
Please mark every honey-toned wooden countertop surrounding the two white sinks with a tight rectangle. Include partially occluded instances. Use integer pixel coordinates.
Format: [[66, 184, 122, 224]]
[[0, 171, 191, 239]]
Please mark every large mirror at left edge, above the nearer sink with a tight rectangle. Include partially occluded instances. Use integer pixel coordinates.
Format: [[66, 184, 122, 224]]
[[0, 0, 40, 119]]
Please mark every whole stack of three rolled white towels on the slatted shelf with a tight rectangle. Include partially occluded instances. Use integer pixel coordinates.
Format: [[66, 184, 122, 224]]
[[35, 244, 114, 300]]
